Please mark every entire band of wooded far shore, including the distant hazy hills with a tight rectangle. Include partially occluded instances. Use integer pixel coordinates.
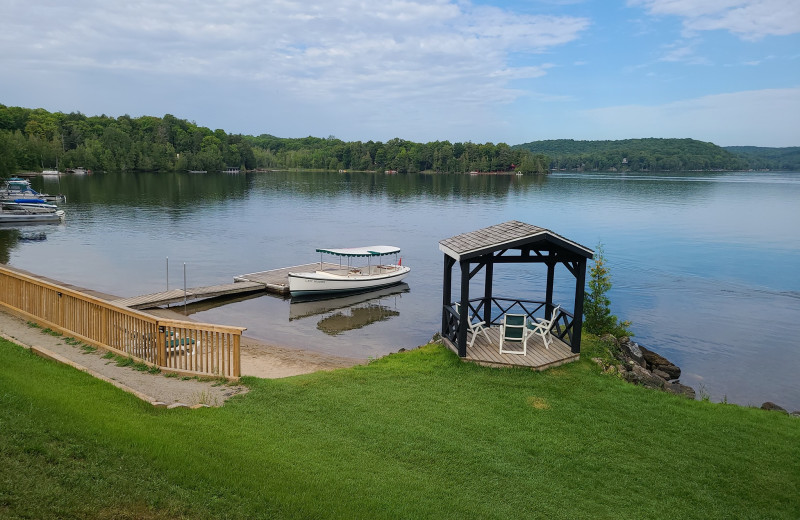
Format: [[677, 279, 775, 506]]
[[0, 104, 800, 176]]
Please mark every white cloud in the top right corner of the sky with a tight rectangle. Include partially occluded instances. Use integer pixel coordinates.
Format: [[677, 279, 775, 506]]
[[628, 0, 800, 40]]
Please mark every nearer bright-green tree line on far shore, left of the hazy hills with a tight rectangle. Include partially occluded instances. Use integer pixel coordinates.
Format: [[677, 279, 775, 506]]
[[0, 104, 550, 176]]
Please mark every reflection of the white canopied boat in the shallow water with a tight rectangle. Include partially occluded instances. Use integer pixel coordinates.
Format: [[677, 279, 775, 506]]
[[289, 283, 409, 336]]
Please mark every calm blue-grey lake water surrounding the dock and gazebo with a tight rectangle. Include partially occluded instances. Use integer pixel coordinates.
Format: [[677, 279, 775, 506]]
[[6, 173, 800, 409]]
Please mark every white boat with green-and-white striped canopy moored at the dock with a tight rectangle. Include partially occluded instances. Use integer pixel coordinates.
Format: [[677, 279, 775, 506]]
[[289, 246, 411, 296]]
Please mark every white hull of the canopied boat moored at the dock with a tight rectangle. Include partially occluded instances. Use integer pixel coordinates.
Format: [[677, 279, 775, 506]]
[[289, 266, 411, 296]]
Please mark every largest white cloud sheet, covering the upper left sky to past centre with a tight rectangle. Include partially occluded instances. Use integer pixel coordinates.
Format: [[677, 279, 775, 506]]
[[0, 0, 589, 112]]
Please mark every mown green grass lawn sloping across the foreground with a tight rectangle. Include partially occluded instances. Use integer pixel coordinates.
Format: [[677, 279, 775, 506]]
[[0, 338, 800, 519]]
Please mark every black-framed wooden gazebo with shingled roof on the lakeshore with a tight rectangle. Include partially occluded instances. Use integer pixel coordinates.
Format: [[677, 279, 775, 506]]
[[439, 220, 594, 370]]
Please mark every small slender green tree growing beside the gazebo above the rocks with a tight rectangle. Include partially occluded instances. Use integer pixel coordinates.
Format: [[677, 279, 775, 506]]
[[583, 244, 631, 337]]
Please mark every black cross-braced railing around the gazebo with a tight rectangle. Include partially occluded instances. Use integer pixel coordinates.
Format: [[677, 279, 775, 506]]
[[442, 298, 575, 346]]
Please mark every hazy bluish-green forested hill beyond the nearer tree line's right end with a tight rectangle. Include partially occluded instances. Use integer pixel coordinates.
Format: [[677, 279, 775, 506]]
[[514, 138, 750, 171]]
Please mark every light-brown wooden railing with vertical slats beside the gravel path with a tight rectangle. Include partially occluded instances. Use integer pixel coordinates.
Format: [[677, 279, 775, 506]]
[[0, 267, 245, 379]]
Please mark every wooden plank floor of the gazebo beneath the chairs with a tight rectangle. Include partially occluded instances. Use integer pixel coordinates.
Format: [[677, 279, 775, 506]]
[[444, 327, 580, 370]]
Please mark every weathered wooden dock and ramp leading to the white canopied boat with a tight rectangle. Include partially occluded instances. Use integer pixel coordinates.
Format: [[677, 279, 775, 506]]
[[112, 262, 339, 309]]
